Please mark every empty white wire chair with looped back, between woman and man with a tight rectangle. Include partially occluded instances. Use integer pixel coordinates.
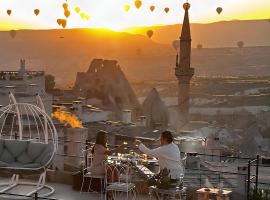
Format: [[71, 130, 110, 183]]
[[105, 163, 136, 200]]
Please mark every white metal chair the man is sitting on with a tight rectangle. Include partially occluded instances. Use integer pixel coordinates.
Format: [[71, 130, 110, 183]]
[[149, 154, 187, 200]]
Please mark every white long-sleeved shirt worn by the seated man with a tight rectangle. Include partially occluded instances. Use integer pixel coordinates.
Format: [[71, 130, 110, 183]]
[[139, 143, 184, 179]]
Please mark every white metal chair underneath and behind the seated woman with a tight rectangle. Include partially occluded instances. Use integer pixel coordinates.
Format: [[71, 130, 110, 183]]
[[81, 146, 105, 199]]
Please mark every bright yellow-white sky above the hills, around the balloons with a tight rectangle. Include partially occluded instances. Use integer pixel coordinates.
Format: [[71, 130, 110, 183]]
[[0, 0, 270, 31]]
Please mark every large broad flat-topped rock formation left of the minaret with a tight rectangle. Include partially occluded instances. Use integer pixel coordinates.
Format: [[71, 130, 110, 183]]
[[73, 59, 140, 117]]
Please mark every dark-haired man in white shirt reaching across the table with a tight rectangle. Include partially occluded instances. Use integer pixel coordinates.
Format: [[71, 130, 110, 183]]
[[134, 131, 183, 180]]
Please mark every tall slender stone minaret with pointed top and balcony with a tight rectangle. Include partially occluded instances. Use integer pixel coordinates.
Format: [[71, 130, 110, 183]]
[[175, 3, 194, 122]]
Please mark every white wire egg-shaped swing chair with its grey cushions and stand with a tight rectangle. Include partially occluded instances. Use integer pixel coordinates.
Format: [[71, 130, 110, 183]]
[[0, 93, 58, 199]]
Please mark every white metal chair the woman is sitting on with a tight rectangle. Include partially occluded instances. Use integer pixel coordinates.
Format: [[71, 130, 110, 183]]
[[81, 147, 105, 199]]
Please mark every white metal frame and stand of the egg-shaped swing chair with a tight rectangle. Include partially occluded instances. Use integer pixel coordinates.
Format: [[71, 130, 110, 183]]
[[0, 92, 58, 199]]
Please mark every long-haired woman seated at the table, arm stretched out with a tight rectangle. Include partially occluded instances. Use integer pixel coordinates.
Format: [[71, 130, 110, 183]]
[[89, 131, 127, 176]]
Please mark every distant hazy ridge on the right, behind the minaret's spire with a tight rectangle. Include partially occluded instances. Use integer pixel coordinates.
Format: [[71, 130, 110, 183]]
[[126, 19, 270, 48]]
